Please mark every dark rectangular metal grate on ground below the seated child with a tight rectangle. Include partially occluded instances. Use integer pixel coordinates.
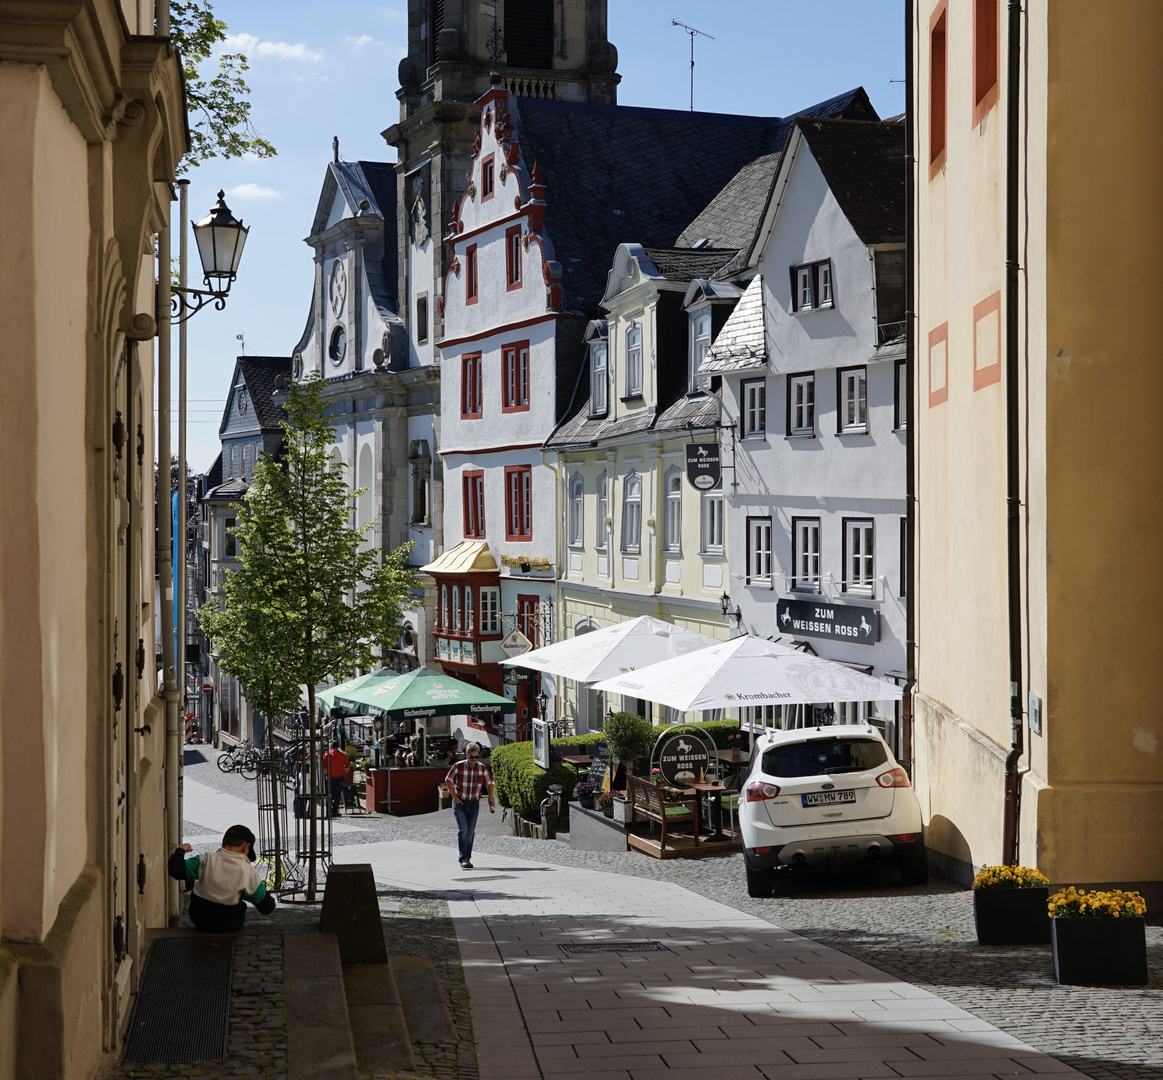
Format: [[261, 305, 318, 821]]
[[122, 935, 234, 1065]]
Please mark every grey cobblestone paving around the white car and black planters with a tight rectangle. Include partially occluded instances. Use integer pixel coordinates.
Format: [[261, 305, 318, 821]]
[[176, 761, 1163, 1080]]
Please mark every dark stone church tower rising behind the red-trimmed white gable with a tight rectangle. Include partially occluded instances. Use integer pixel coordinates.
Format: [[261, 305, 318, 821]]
[[384, 0, 621, 353]]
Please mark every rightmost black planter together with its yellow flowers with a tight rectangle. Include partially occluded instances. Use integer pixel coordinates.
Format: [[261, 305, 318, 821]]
[[1049, 886, 1147, 986]]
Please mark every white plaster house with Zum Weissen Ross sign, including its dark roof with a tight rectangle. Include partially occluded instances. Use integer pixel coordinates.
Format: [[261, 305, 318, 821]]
[[700, 119, 906, 737]]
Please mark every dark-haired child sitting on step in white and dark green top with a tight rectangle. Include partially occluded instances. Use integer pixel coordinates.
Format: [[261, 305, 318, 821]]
[[167, 825, 274, 934]]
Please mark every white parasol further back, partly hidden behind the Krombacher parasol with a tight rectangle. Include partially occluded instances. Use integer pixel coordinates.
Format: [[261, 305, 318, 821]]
[[502, 615, 715, 683]]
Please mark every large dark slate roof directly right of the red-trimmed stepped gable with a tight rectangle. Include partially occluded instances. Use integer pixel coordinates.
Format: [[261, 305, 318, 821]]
[[518, 87, 877, 314]]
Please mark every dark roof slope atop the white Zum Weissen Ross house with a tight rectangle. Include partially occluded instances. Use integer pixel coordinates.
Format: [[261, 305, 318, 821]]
[[799, 117, 905, 244]]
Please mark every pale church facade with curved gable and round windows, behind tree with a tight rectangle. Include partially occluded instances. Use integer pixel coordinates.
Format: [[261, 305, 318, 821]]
[[292, 156, 442, 674]]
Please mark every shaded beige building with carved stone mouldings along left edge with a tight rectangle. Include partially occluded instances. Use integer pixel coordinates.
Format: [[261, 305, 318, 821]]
[[0, 0, 188, 1080]]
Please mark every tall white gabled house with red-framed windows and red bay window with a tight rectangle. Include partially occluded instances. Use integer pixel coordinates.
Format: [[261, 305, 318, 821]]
[[426, 86, 585, 738]]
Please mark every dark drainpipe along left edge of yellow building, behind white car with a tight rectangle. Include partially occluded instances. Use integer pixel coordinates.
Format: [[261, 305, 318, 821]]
[[897, 0, 918, 760]]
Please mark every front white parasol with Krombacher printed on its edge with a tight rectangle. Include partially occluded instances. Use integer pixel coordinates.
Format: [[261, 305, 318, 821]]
[[594, 635, 901, 713]]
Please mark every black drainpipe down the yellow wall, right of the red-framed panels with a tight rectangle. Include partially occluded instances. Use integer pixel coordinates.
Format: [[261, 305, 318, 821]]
[[1001, 0, 1022, 865]]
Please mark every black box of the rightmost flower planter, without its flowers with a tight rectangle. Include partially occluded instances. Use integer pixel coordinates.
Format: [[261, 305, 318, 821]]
[[1050, 915, 1147, 986]]
